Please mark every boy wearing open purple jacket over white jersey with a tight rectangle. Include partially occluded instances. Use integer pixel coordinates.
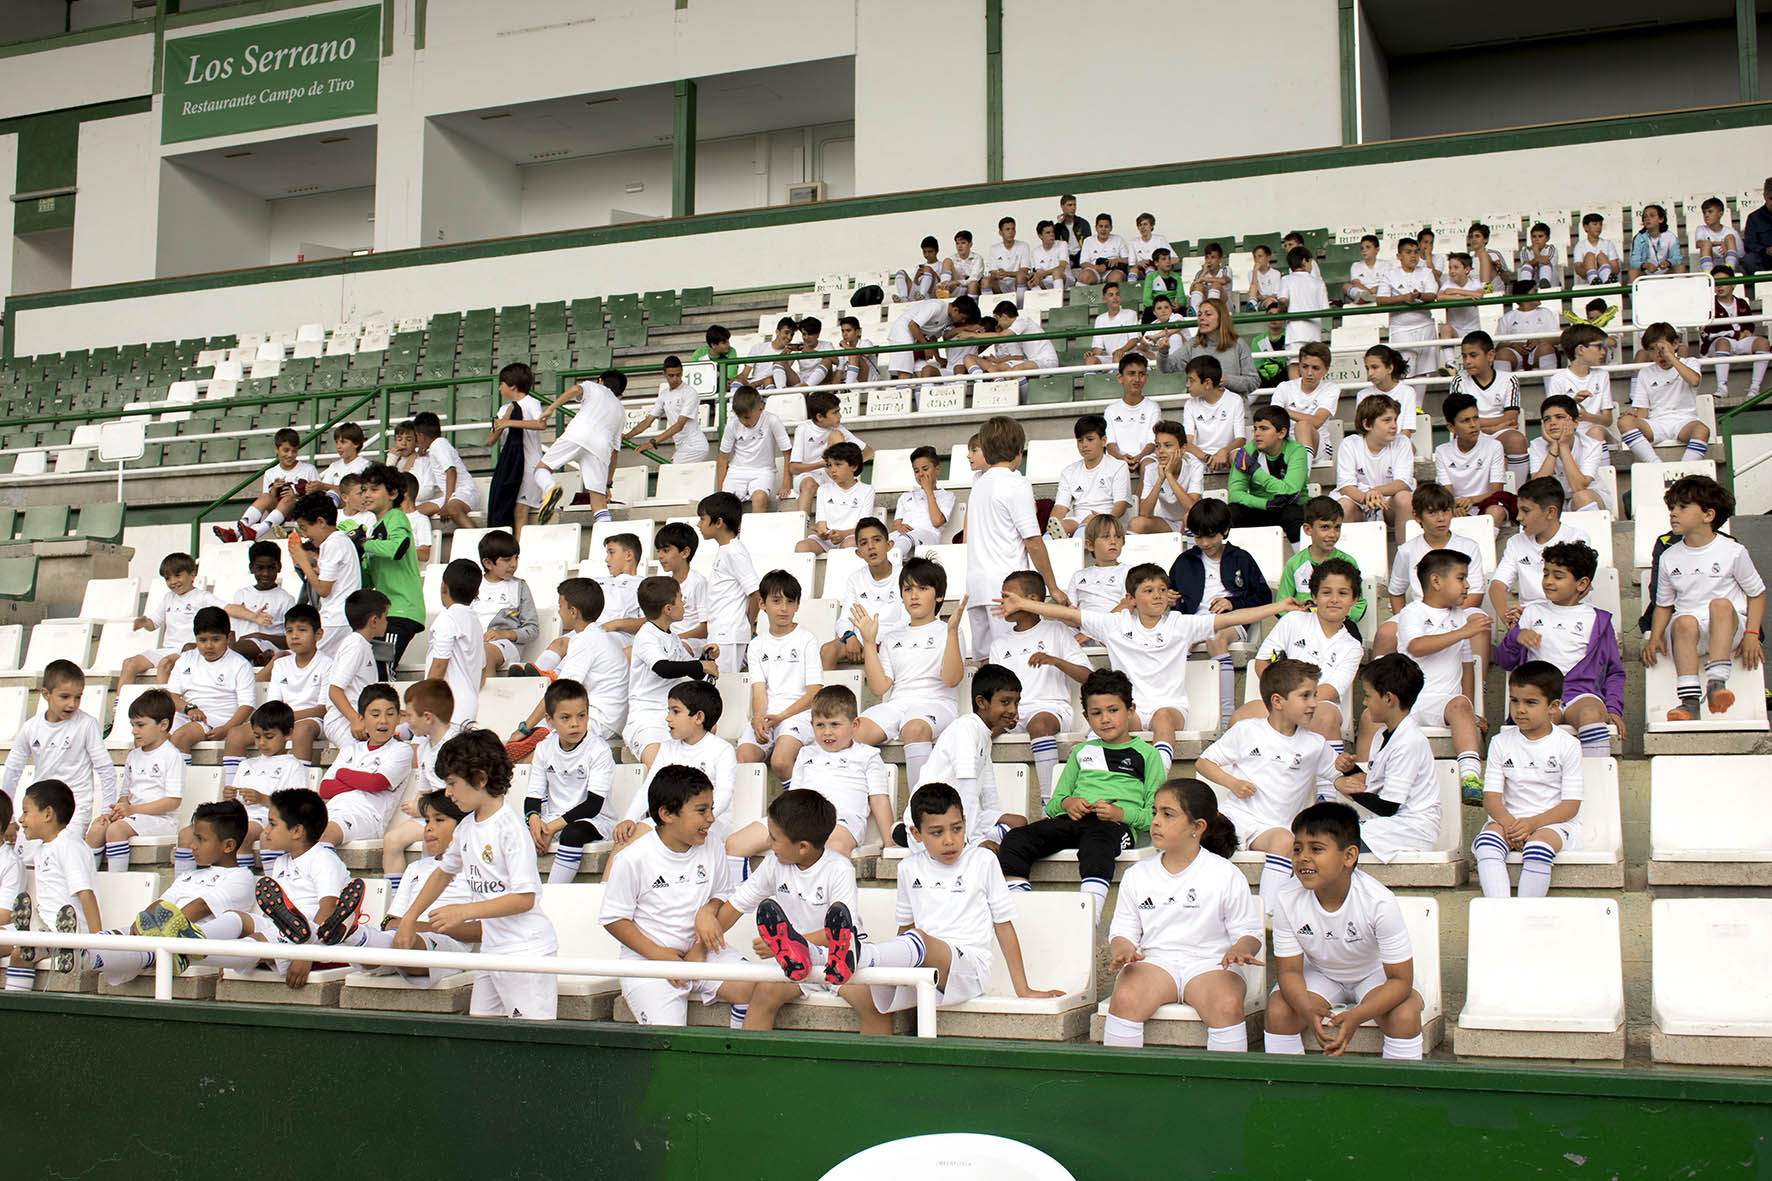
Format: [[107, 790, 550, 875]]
[[1496, 541, 1625, 759]]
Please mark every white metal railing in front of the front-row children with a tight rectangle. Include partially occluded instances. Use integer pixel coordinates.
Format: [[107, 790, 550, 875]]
[[0, 931, 936, 1037]]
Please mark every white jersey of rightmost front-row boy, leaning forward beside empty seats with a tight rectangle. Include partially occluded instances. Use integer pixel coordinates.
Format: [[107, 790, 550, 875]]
[[1269, 869, 1416, 984]]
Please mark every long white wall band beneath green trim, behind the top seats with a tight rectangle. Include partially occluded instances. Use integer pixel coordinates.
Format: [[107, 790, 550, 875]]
[[14, 120, 1765, 353]]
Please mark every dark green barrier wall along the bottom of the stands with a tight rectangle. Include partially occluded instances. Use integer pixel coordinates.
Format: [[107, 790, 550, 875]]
[[0, 995, 1772, 1181]]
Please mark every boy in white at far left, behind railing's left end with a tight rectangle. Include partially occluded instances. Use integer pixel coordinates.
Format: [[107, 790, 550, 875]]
[[5, 778, 99, 993]]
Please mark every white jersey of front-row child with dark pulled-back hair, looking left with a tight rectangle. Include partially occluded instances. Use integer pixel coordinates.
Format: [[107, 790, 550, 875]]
[[1108, 849, 1262, 961]]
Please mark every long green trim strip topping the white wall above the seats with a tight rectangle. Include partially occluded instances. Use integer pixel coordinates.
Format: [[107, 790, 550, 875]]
[[4, 103, 1772, 340]]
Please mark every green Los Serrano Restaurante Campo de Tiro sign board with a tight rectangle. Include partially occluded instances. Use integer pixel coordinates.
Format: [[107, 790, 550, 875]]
[[159, 5, 381, 144]]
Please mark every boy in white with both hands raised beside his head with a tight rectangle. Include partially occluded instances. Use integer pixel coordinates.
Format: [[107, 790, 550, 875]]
[[854, 559, 966, 787]]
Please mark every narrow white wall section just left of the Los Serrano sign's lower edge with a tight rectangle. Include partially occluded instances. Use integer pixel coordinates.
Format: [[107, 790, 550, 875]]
[[73, 110, 159, 287]]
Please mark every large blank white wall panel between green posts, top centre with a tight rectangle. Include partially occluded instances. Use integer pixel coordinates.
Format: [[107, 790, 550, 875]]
[[1006, 0, 1341, 175]]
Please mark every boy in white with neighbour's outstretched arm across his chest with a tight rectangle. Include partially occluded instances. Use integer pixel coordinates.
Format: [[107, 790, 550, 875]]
[[991, 569, 1090, 805]]
